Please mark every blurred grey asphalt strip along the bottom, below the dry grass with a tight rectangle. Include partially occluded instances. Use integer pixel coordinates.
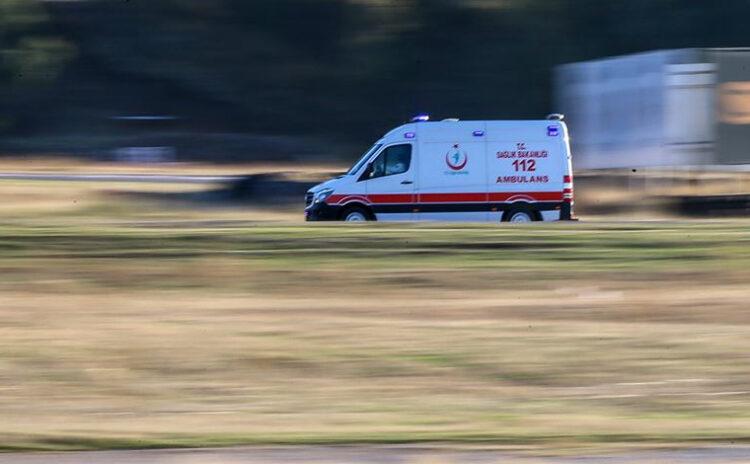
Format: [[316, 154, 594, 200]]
[[0, 446, 750, 464]]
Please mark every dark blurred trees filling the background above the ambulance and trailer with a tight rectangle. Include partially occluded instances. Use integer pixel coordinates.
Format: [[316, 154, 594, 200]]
[[0, 0, 750, 159]]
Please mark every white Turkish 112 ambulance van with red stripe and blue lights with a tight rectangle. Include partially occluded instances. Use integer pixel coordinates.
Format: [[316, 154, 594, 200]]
[[305, 115, 574, 222]]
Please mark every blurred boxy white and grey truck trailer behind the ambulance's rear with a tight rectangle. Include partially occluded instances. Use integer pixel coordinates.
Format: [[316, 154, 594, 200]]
[[555, 48, 750, 169]]
